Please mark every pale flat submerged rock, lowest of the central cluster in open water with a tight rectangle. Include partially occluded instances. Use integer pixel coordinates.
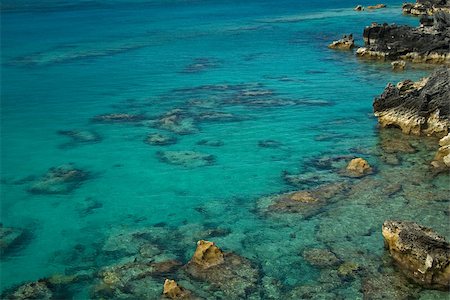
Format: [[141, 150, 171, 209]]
[[157, 151, 215, 168]]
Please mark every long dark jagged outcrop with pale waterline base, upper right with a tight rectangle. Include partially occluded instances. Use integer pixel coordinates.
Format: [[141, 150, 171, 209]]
[[357, 12, 450, 64]]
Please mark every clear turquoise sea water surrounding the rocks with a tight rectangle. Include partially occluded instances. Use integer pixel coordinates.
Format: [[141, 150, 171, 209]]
[[0, 0, 449, 299]]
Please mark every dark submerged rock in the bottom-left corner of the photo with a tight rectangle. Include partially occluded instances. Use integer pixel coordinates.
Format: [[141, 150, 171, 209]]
[[1, 280, 53, 300]]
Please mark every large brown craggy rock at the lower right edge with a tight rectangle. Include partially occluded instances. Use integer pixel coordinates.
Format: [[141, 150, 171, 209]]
[[382, 221, 450, 290]]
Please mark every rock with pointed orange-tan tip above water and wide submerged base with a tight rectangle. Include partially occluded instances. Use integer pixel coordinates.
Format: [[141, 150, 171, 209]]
[[185, 241, 259, 299]]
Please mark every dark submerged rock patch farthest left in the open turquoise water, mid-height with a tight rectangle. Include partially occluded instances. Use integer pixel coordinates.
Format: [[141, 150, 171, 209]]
[[28, 164, 90, 194]]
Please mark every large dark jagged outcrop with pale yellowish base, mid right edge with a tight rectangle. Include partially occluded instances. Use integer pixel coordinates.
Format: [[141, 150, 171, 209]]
[[373, 67, 450, 137]]
